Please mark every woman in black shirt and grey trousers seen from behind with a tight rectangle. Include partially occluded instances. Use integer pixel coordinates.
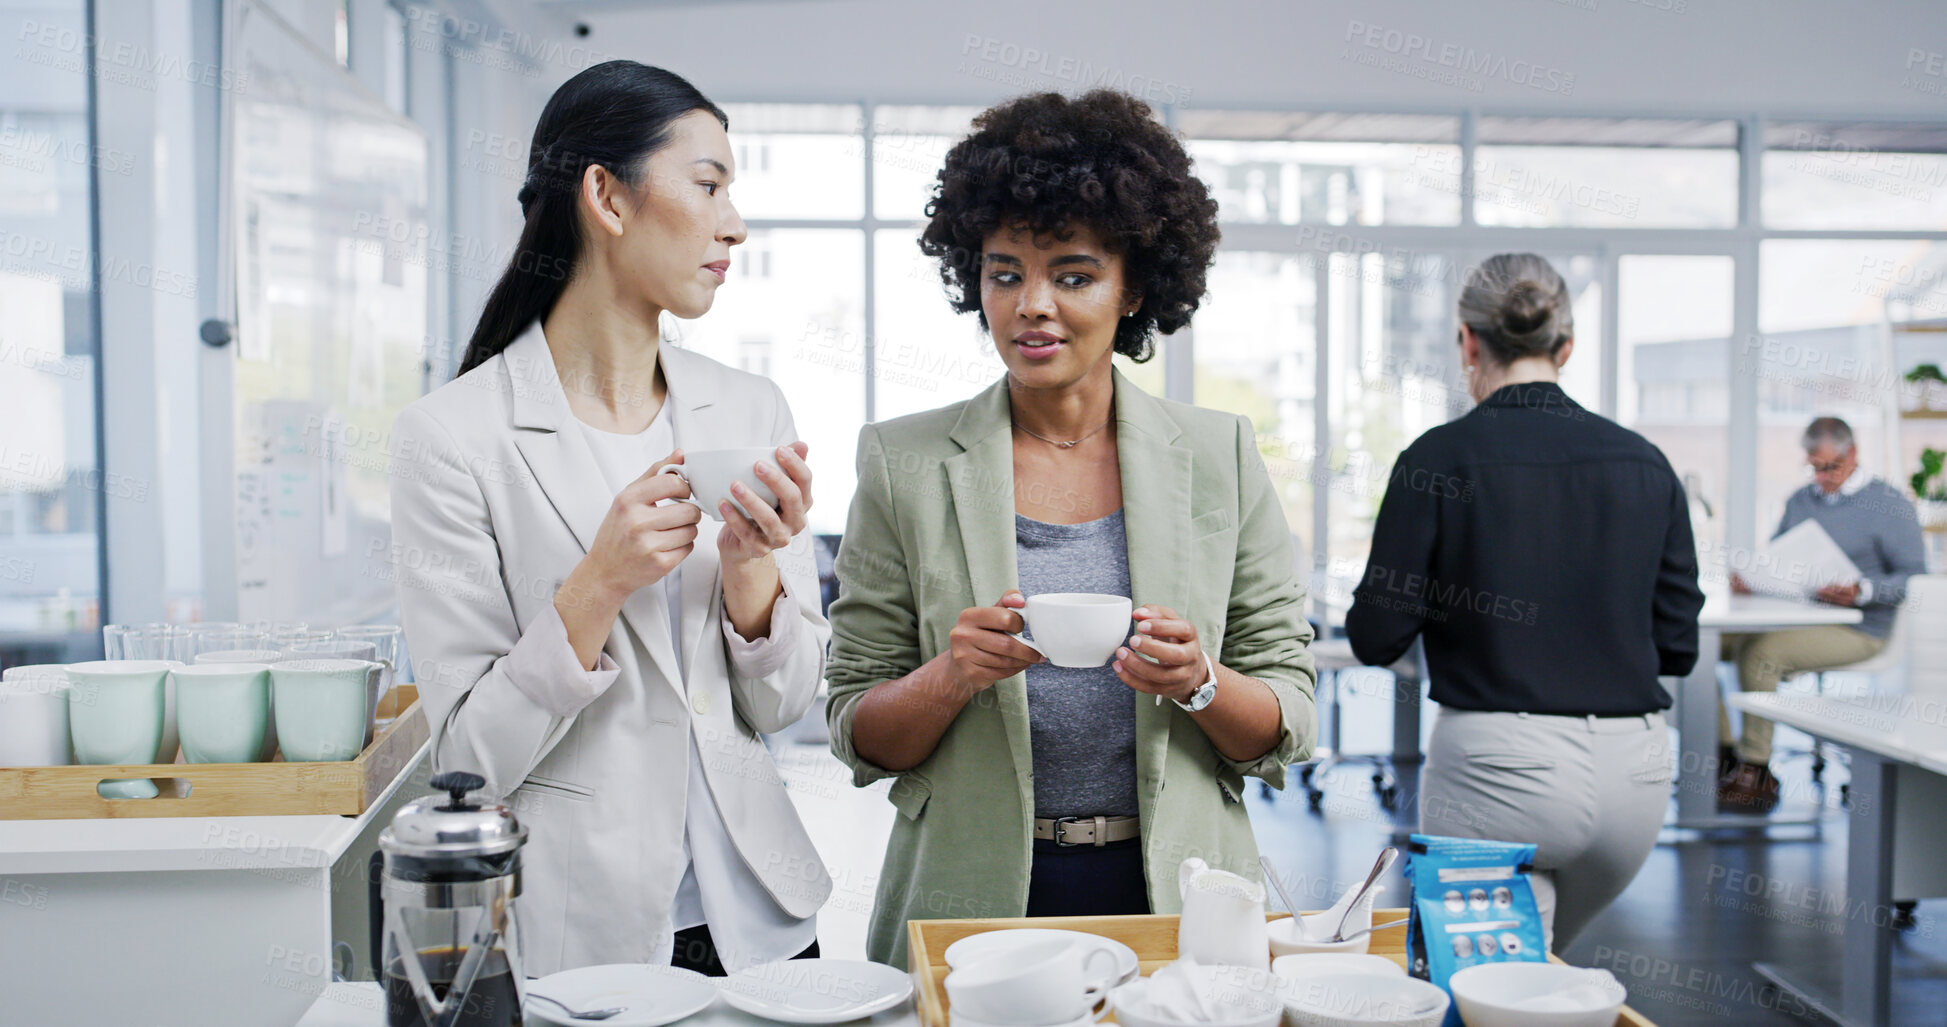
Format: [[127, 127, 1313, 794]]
[[1345, 253, 1704, 949]]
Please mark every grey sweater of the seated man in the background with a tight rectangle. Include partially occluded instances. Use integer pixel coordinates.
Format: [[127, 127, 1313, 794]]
[[1772, 477, 1928, 639]]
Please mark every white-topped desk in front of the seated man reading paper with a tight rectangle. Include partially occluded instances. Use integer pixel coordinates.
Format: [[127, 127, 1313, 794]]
[[1671, 596, 1861, 828]]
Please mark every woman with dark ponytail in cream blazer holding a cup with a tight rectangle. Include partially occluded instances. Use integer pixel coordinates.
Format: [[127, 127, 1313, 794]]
[[391, 60, 831, 974]]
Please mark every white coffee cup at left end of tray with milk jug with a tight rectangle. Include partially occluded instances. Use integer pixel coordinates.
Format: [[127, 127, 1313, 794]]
[[946, 939, 1118, 1027]]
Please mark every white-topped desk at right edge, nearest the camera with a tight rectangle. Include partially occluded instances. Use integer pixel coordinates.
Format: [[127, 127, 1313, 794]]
[[1731, 692, 1947, 1027]]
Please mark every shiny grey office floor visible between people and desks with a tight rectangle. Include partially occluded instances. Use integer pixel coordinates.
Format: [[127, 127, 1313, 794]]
[[779, 670, 1947, 1027]]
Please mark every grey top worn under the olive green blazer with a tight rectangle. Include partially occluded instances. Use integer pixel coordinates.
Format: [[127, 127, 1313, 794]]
[[1014, 511, 1135, 817]]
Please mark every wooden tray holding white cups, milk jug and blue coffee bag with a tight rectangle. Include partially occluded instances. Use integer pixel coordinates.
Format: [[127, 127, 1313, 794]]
[[905, 910, 1655, 1027]]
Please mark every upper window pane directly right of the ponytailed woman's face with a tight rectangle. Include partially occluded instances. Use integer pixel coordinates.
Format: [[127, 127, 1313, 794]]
[[724, 103, 864, 218]]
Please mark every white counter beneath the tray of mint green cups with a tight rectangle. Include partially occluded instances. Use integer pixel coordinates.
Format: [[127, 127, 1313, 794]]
[[0, 746, 426, 1027]]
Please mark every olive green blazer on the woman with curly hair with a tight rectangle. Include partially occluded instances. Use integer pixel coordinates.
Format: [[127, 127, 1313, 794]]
[[826, 372, 1318, 967]]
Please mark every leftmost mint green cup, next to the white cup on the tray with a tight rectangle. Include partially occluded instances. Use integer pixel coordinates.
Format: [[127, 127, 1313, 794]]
[[68, 661, 179, 799]]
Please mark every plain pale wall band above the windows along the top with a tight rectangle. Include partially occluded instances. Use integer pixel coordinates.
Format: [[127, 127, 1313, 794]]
[[576, 0, 1947, 119]]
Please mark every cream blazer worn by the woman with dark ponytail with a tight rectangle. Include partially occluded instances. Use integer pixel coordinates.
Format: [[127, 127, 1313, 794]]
[[391, 325, 831, 976]]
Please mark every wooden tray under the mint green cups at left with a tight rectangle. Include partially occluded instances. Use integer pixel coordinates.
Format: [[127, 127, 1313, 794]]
[[0, 684, 428, 820]]
